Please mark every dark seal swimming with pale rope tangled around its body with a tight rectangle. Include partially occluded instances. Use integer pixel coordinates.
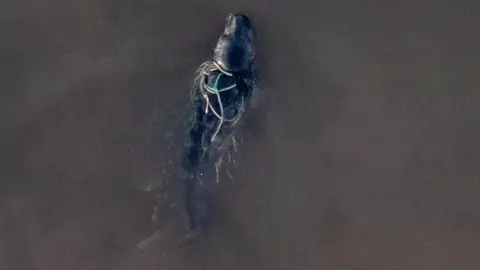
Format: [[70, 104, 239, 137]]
[[182, 14, 256, 229]]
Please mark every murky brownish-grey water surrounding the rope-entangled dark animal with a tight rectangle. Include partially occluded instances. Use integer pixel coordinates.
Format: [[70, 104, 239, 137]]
[[0, 0, 480, 270]]
